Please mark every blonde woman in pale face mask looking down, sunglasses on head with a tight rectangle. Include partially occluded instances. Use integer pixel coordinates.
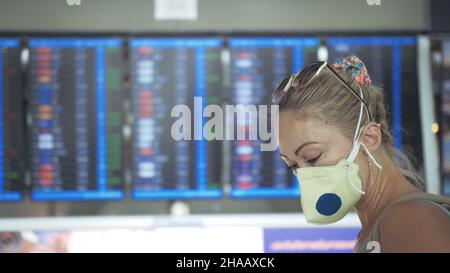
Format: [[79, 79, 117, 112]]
[[273, 56, 450, 252]]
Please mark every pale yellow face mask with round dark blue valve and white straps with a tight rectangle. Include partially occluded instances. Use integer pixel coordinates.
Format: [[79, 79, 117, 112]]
[[296, 86, 382, 224]]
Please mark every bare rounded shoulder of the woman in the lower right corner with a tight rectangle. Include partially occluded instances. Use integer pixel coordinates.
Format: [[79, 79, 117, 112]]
[[380, 197, 450, 252]]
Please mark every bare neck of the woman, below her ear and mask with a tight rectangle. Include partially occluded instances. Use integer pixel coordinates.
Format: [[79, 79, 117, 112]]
[[355, 151, 418, 230]]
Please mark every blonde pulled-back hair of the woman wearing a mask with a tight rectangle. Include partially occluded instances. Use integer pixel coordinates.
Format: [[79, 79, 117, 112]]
[[274, 64, 424, 190]]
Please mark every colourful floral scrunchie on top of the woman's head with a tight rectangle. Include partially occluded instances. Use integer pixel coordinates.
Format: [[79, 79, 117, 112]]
[[331, 55, 372, 85]]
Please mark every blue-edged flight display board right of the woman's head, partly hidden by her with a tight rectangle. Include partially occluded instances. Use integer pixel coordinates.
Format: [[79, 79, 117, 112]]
[[327, 36, 422, 164]]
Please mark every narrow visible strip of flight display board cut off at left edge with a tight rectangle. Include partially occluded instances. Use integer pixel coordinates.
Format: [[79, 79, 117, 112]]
[[0, 38, 24, 202]]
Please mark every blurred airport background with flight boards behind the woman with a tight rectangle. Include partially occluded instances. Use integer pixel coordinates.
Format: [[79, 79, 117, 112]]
[[0, 0, 450, 252]]
